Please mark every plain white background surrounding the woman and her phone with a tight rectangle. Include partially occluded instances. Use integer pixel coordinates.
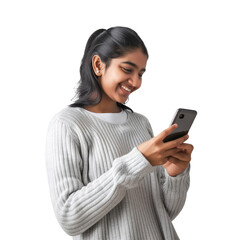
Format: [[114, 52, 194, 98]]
[[0, 0, 233, 240]]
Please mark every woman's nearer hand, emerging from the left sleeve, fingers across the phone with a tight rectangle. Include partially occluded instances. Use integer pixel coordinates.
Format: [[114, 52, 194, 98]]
[[137, 124, 188, 166]]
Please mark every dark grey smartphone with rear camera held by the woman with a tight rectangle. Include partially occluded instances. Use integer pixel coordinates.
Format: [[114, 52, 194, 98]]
[[163, 108, 197, 142]]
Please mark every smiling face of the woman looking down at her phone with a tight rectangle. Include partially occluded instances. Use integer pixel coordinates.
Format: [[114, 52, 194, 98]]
[[96, 49, 147, 103]]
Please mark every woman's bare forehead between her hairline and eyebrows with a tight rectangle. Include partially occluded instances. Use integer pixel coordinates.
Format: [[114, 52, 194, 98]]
[[112, 49, 147, 69]]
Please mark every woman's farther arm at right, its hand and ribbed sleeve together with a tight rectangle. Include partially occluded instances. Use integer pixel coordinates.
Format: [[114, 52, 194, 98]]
[[140, 121, 193, 220]]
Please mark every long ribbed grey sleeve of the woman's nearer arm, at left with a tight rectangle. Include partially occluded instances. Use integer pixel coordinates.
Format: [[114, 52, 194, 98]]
[[46, 120, 153, 236]]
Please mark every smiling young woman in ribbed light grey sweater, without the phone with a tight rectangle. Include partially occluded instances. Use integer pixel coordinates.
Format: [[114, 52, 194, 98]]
[[46, 27, 193, 240]]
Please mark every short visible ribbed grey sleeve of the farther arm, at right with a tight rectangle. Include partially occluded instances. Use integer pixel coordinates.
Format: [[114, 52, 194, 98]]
[[160, 165, 190, 220]]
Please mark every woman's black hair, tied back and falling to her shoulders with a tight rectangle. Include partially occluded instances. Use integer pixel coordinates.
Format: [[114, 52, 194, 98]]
[[69, 27, 149, 112]]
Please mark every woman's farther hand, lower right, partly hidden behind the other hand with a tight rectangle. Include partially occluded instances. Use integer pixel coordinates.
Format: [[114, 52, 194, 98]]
[[163, 143, 193, 177]]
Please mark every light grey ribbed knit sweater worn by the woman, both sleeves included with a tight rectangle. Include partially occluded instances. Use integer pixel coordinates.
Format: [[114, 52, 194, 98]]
[[46, 107, 189, 240]]
